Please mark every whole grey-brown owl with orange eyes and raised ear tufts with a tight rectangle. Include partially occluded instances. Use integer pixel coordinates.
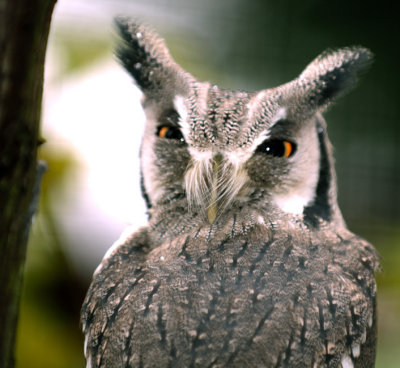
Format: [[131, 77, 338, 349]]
[[81, 17, 379, 368]]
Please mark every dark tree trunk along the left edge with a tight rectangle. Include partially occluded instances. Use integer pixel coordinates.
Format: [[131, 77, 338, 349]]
[[0, 0, 56, 368]]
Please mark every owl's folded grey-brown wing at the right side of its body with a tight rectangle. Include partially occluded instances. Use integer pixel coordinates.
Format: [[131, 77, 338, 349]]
[[304, 233, 379, 368]]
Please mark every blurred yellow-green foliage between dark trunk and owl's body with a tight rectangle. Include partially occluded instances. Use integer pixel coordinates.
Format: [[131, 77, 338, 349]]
[[16, 146, 87, 368]]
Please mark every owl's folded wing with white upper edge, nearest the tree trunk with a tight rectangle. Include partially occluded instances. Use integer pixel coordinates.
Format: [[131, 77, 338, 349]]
[[81, 228, 153, 367]]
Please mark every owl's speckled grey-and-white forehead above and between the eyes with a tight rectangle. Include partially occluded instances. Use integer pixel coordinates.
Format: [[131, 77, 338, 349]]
[[175, 84, 282, 149]]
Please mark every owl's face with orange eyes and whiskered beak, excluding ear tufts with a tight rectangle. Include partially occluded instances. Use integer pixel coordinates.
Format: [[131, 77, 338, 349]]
[[141, 83, 321, 222]]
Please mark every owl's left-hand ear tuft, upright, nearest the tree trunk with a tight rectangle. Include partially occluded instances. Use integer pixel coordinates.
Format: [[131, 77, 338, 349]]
[[115, 17, 194, 100]]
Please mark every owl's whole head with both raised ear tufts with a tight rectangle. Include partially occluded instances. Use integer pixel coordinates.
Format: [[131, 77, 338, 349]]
[[116, 18, 371, 229]]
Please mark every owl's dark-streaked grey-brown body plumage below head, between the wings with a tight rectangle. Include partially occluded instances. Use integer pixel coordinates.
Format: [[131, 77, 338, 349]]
[[82, 229, 375, 367]]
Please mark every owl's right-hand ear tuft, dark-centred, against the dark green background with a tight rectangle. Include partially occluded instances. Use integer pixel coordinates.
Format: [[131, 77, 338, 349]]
[[295, 46, 372, 109]]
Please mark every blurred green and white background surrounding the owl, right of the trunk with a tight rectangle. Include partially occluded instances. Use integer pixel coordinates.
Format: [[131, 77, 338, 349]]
[[17, 0, 400, 368]]
